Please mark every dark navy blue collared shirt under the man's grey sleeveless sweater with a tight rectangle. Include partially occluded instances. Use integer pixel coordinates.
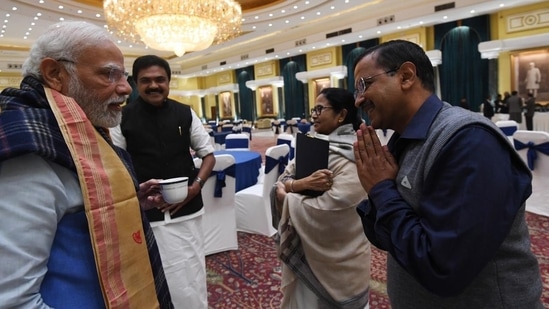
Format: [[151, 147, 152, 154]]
[[358, 95, 531, 296]]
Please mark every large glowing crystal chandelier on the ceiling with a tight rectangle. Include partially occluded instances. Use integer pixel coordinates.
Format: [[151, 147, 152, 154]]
[[103, 0, 242, 57]]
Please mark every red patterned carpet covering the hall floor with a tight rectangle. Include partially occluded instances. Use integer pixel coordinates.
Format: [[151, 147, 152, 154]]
[[206, 136, 549, 309]]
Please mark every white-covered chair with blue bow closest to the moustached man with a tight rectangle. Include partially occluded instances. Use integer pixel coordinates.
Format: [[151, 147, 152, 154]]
[[195, 154, 238, 255]]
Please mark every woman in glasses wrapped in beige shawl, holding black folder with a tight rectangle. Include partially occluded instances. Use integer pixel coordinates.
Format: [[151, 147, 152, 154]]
[[276, 88, 371, 309]]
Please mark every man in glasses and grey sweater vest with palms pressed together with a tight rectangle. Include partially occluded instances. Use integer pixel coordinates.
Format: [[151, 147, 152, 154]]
[[354, 40, 543, 309]]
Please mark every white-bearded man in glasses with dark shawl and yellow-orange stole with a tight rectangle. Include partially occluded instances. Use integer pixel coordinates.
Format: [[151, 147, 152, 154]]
[[0, 22, 173, 309]]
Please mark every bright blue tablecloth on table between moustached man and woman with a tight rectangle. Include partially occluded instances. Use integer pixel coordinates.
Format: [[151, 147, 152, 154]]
[[214, 150, 261, 191]]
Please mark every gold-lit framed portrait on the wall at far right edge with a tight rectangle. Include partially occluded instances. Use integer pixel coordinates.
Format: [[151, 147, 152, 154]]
[[511, 48, 549, 102]]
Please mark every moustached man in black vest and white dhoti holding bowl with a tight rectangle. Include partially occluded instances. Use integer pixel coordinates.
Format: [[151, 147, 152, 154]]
[[112, 55, 215, 309]]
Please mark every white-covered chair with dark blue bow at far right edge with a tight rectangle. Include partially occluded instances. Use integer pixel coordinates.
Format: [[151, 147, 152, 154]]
[[513, 130, 549, 216]]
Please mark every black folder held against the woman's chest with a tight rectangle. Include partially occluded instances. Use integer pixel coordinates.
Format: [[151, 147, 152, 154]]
[[295, 133, 330, 196]]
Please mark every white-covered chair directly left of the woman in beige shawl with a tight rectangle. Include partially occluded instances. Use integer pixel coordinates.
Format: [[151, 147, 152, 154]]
[[235, 144, 290, 236]]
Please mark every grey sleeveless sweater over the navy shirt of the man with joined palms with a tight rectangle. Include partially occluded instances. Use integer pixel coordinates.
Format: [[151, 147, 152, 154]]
[[387, 104, 543, 309]]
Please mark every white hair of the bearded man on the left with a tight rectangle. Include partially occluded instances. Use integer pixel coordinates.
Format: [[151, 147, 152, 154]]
[[23, 21, 113, 81]]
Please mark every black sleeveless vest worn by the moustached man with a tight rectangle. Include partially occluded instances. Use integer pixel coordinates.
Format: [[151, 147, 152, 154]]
[[120, 98, 203, 221]]
